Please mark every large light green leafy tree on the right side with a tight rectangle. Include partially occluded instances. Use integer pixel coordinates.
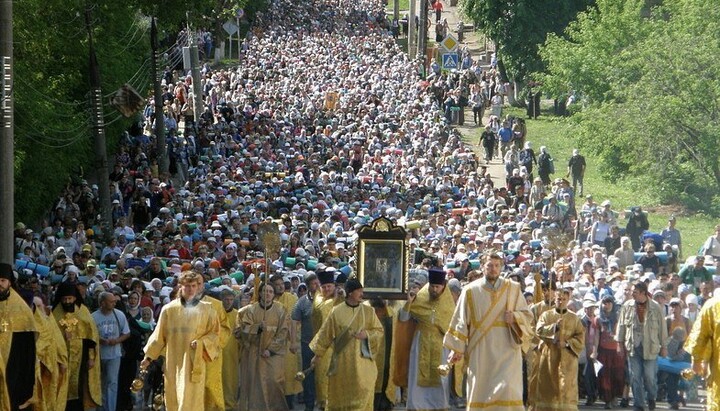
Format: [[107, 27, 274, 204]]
[[540, 0, 720, 215]]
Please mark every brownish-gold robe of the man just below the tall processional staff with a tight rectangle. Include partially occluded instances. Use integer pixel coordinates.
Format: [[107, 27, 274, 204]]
[[237, 302, 290, 411]]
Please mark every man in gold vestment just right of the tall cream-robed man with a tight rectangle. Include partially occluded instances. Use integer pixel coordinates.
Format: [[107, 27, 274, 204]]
[[528, 289, 585, 411]]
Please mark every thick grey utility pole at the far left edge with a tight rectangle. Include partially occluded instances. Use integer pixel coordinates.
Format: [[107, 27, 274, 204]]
[[0, 0, 15, 266]]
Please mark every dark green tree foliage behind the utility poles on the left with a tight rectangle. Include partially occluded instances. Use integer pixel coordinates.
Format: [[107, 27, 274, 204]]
[[13, 0, 266, 222]]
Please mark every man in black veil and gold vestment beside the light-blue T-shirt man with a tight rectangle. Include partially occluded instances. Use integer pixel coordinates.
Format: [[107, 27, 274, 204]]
[[53, 282, 102, 411]]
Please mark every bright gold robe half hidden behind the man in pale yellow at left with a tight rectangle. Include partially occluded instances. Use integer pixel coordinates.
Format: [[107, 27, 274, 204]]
[[200, 296, 232, 411]]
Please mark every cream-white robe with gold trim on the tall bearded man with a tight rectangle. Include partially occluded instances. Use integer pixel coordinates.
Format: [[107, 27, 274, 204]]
[[443, 278, 533, 411]]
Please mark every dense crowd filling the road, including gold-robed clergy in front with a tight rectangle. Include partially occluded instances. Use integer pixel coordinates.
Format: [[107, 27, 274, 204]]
[[0, 0, 720, 411]]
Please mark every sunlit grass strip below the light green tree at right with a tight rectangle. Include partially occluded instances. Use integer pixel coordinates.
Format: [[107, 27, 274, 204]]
[[464, 102, 717, 258]]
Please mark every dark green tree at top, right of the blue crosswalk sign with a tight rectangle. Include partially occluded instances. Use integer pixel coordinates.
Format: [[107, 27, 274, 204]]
[[462, 0, 594, 83]]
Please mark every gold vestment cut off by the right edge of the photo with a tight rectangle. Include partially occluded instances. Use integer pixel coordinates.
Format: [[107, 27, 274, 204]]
[[684, 296, 720, 411]]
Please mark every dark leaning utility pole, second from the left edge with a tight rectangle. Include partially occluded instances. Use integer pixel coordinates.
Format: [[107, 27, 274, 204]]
[[85, 8, 112, 240]]
